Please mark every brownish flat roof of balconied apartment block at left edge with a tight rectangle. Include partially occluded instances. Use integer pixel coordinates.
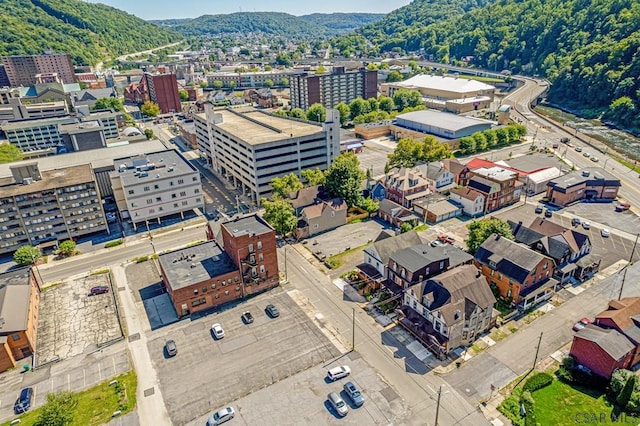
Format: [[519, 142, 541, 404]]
[[0, 163, 93, 198]]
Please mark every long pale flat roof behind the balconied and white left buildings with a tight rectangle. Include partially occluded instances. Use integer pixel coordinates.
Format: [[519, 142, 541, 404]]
[[0, 140, 166, 176]]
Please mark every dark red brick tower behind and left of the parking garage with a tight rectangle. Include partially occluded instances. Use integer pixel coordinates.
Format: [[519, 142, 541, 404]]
[[124, 72, 182, 114]]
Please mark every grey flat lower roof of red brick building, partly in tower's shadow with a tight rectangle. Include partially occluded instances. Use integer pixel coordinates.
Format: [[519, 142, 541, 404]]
[[158, 241, 240, 290]]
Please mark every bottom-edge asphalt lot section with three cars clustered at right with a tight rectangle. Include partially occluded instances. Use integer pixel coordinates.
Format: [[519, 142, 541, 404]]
[[189, 352, 416, 426]]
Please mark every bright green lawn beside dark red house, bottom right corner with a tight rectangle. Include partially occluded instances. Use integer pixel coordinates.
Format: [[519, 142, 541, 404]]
[[533, 380, 614, 426]]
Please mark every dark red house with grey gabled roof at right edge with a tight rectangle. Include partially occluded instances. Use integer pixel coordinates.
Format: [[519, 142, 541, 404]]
[[569, 297, 640, 379]]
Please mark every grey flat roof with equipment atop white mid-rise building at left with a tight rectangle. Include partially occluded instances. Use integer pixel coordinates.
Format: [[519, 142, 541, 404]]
[[111, 150, 196, 186]]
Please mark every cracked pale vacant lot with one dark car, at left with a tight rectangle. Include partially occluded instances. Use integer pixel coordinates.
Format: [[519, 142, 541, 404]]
[[36, 273, 122, 365]]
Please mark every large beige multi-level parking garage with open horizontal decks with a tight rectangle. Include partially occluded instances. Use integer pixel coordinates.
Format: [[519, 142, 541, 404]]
[[201, 107, 340, 203]]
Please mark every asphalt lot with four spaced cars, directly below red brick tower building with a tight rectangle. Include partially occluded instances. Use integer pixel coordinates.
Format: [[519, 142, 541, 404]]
[[148, 289, 340, 424]]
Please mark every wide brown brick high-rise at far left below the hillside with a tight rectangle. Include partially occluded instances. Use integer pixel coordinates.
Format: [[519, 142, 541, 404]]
[[2, 53, 77, 87]]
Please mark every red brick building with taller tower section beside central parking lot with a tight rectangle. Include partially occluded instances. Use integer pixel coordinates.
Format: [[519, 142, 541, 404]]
[[158, 215, 280, 317]]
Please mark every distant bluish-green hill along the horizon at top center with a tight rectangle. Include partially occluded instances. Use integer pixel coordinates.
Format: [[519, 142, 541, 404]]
[[162, 12, 384, 39]]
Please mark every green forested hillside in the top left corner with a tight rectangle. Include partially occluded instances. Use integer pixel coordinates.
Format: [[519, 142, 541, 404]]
[[0, 0, 182, 65]]
